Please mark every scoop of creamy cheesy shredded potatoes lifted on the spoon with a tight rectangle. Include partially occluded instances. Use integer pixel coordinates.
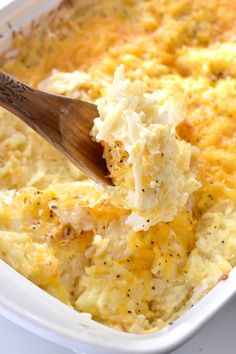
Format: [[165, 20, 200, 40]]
[[92, 66, 199, 231]]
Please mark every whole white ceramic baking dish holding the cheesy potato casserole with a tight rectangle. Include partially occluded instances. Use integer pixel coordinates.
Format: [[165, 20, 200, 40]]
[[0, 0, 236, 354]]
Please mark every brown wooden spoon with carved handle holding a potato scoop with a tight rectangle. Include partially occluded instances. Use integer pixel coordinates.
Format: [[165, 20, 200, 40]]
[[0, 71, 111, 184]]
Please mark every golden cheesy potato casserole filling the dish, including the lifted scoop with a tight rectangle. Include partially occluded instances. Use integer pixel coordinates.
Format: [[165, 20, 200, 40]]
[[0, 0, 236, 333]]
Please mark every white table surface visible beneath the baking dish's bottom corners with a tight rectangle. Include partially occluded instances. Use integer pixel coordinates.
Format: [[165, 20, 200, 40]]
[[0, 297, 236, 354]]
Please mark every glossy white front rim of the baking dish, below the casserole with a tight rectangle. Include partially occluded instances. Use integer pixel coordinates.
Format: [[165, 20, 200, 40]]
[[0, 260, 236, 354]]
